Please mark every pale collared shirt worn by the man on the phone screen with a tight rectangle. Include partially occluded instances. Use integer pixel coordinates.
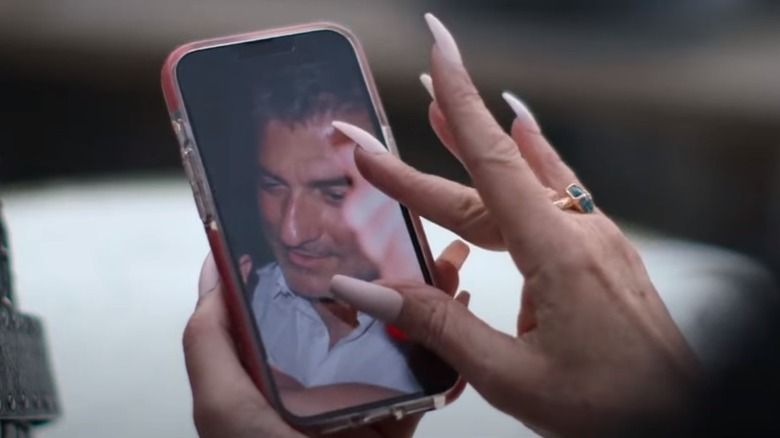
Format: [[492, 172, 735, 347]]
[[252, 263, 421, 393]]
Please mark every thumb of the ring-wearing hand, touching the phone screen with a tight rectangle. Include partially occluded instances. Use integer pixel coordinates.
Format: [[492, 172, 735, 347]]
[[330, 275, 532, 392]]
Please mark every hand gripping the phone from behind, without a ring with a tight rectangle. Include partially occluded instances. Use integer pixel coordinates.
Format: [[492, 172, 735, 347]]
[[183, 241, 468, 438]]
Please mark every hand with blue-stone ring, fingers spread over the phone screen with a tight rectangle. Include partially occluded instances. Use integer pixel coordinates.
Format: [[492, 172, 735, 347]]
[[331, 16, 700, 436]]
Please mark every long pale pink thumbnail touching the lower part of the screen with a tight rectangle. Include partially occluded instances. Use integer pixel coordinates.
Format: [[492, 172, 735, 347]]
[[330, 275, 404, 323]]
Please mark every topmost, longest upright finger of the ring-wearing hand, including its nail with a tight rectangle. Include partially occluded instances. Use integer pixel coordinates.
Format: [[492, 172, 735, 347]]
[[426, 14, 562, 270]]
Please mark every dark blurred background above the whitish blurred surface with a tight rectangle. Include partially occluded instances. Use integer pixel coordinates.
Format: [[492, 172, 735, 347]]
[[0, 0, 780, 438]]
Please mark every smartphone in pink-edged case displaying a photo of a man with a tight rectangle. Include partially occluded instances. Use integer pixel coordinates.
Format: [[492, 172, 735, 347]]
[[162, 23, 464, 433]]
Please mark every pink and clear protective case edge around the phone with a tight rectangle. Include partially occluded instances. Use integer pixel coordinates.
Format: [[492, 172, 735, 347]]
[[162, 22, 465, 433]]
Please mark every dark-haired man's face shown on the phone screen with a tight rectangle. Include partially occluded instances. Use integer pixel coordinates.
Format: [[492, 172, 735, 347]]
[[257, 112, 377, 297]]
